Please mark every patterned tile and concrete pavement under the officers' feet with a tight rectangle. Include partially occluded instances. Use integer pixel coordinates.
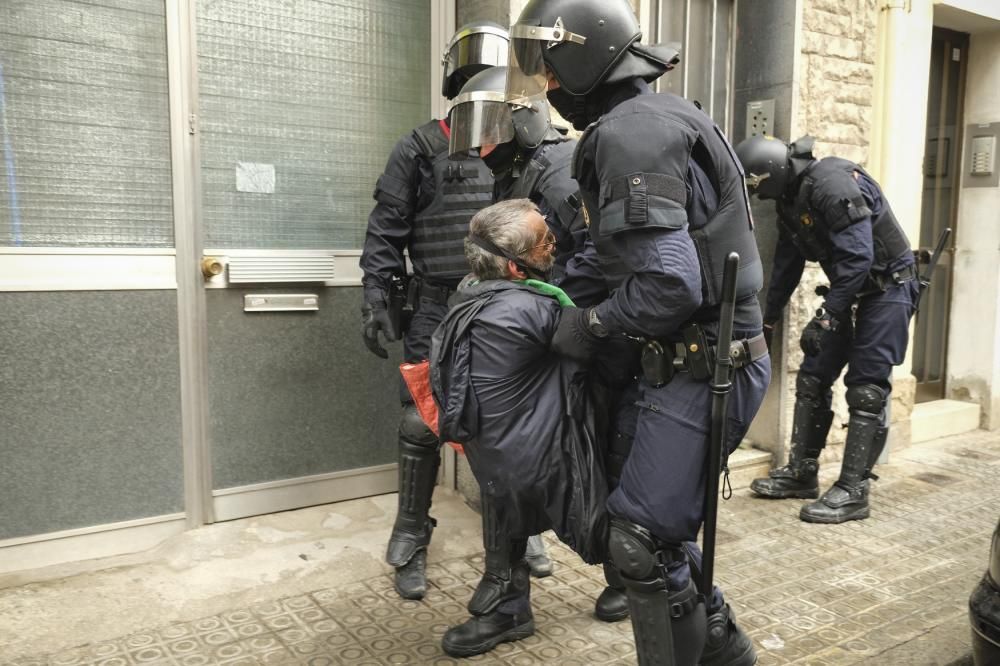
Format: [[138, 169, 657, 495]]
[[0, 431, 1000, 666]]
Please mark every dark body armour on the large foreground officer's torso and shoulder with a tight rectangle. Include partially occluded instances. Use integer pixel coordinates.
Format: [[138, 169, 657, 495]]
[[573, 94, 764, 321]]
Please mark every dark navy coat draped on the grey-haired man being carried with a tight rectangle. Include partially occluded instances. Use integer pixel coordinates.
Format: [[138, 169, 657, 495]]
[[431, 281, 607, 563]]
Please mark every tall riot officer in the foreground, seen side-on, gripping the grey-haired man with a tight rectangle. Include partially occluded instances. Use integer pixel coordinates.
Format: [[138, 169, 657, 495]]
[[507, 0, 770, 666]]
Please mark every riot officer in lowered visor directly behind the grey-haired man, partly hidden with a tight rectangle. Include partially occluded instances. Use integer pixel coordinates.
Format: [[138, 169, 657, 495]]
[[442, 67, 627, 657]]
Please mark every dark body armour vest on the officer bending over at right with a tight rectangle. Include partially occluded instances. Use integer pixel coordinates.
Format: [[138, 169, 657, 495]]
[[778, 157, 911, 275]]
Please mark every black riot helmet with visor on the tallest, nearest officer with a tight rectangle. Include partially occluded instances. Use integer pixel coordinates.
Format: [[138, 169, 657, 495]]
[[507, 0, 678, 100]]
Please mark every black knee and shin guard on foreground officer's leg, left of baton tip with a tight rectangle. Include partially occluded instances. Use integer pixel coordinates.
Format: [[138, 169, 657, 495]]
[[608, 518, 706, 666]]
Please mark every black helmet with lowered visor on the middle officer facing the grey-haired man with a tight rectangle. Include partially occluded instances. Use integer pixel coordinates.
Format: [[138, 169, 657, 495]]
[[448, 67, 555, 159]]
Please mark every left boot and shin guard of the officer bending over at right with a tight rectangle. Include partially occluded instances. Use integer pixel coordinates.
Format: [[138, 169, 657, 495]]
[[750, 372, 833, 499]]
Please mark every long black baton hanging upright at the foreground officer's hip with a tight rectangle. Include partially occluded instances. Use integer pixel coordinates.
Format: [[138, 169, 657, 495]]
[[701, 252, 740, 599]]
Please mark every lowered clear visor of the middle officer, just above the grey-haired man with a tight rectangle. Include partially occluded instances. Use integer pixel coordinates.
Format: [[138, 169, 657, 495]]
[[448, 91, 514, 160]]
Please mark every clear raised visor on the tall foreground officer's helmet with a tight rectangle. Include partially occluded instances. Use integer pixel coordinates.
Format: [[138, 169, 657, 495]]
[[506, 18, 587, 104]]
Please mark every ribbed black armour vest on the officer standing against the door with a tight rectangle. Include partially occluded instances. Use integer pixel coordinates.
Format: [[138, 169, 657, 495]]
[[409, 120, 493, 287]]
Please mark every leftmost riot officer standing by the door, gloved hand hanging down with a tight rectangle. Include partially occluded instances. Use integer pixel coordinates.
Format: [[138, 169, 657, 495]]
[[361, 21, 551, 599]]
